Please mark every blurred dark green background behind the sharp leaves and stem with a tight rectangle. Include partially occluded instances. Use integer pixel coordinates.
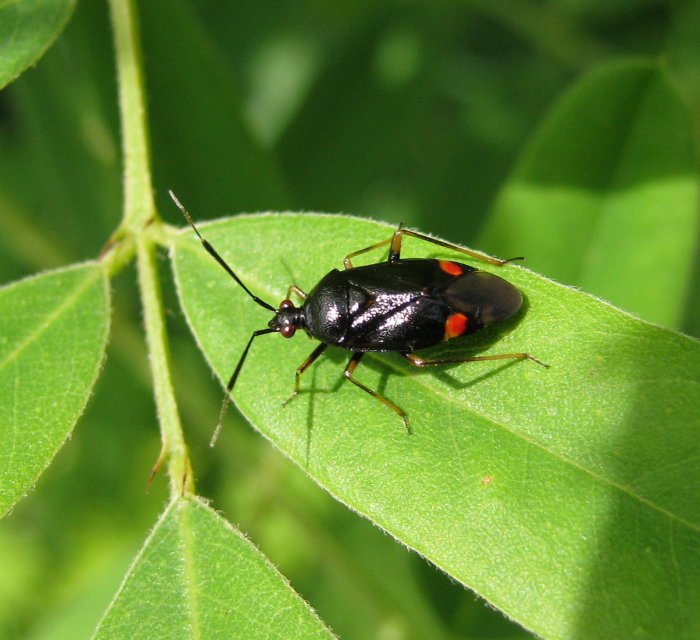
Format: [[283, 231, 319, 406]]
[[0, 0, 700, 640]]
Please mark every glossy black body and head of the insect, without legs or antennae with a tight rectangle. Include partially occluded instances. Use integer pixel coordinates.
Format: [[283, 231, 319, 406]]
[[276, 259, 522, 353]]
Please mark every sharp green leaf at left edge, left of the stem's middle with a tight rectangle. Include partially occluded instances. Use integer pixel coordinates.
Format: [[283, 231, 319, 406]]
[[0, 263, 109, 515]]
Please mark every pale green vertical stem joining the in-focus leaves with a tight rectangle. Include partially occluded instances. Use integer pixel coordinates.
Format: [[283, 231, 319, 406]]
[[109, 0, 194, 497]]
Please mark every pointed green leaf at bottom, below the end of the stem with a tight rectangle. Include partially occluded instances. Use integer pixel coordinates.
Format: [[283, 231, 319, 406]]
[[93, 498, 334, 640]]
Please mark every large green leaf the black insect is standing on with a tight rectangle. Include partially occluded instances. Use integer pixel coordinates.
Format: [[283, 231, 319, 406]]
[[173, 214, 700, 638]]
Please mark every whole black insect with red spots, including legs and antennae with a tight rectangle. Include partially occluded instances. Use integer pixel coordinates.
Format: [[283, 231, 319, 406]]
[[170, 192, 547, 439]]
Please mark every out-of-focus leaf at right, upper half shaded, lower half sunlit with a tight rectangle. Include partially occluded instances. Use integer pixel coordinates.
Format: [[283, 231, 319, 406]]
[[482, 62, 700, 327]]
